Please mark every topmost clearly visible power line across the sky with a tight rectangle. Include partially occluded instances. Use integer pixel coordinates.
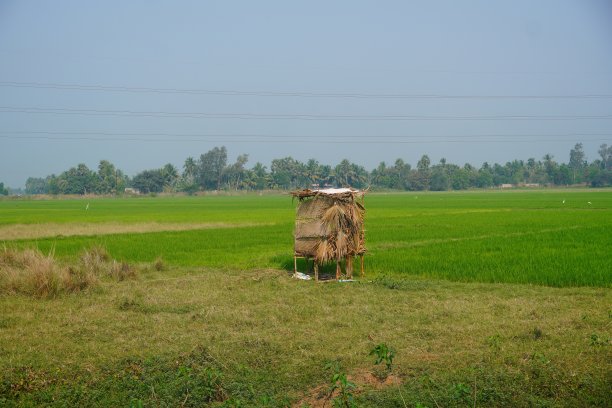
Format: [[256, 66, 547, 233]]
[[0, 81, 612, 100]]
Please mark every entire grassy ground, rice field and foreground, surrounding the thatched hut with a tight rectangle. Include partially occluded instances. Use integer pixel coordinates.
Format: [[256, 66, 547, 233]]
[[0, 190, 612, 407]]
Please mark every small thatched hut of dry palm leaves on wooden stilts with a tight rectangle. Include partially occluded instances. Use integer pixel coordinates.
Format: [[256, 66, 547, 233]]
[[291, 188, 366, 280]]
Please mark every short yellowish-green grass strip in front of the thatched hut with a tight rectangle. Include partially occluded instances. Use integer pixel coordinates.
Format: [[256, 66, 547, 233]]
[[0, 270, 612, 406]]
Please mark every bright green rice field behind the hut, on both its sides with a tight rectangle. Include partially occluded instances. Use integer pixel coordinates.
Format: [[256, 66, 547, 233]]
[[0, 190, 612, 287]]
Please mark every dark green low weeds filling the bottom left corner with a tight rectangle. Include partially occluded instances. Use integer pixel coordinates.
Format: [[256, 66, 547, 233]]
[[0, 347, 227, 408]]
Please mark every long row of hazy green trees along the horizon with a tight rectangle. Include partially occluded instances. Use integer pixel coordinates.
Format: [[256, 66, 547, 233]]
[[21, 143, 612, 194]]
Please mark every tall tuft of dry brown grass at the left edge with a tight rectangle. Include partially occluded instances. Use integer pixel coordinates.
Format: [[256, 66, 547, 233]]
[[0, 246, 137, 298]]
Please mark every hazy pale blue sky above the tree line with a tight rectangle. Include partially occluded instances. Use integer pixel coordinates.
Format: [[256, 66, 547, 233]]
[[0, 0, 612, 187]]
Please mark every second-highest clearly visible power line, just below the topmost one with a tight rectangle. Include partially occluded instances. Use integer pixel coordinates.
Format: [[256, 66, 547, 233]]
[[0, 106, 612, 121]]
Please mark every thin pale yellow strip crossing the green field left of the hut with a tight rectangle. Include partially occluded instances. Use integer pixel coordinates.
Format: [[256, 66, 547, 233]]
[[0, 222, 273, 241]]
